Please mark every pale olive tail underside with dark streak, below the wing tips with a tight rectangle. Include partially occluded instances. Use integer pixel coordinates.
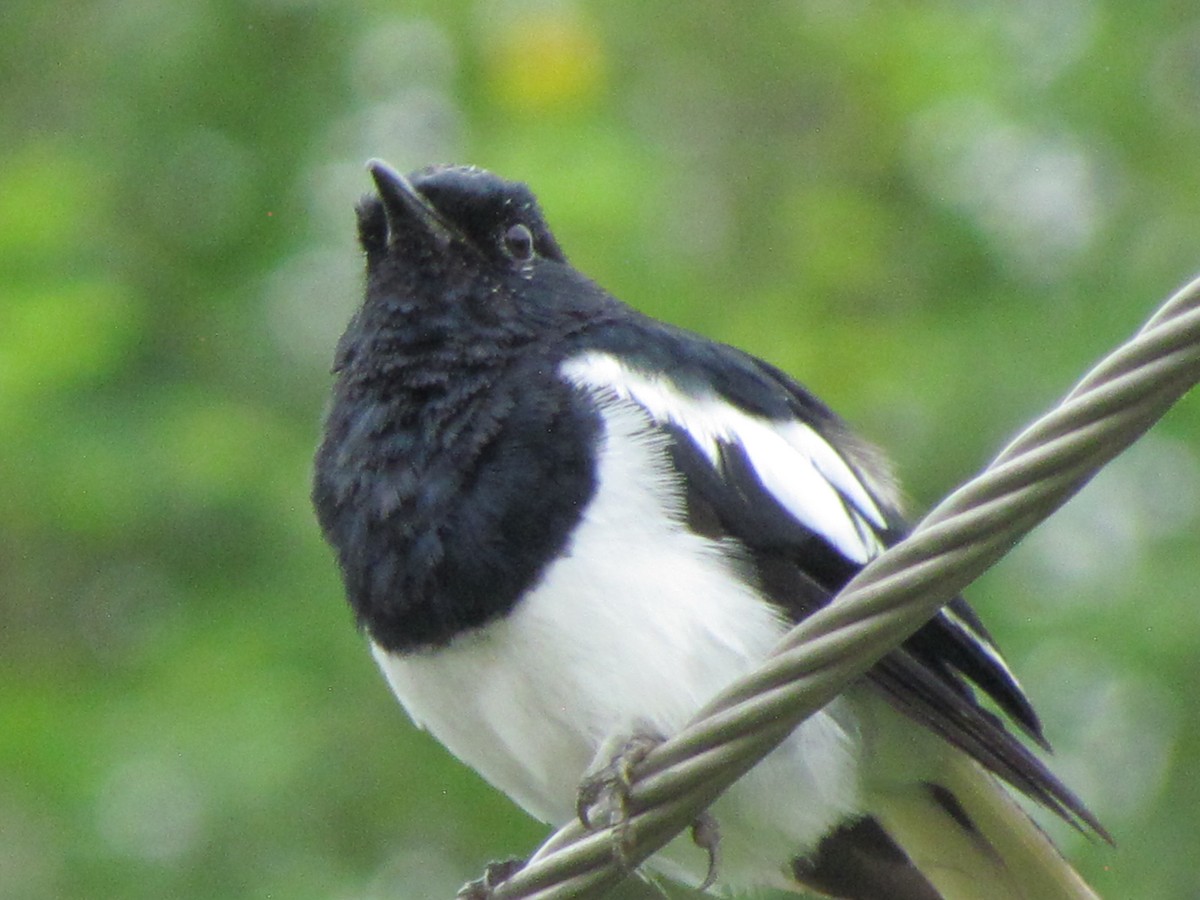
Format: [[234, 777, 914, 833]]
[[875, 752, 1098, 900]]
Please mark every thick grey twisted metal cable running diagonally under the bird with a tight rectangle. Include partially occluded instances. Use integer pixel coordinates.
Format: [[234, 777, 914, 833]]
[[482, 278, 1200, 900]]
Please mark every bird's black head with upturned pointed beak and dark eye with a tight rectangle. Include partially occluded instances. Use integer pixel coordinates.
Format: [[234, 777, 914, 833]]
[[335, 161, 613, 371]]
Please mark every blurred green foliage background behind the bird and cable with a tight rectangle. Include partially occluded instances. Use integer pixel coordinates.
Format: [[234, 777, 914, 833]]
[[0, 0, 1200, 900]]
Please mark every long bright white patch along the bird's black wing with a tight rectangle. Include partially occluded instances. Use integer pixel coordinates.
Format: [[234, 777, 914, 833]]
[[560, 352, 886, 565]]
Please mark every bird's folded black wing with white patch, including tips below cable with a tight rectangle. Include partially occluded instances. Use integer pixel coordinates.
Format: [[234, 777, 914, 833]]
[[562, 343, 1104, 834]]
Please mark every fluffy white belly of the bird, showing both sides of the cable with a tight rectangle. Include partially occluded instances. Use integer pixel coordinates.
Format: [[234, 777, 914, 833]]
[[373, 404, 859, 884]]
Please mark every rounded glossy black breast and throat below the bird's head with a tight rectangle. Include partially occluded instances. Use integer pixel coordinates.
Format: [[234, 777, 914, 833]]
[[313, 303, 600, 652]]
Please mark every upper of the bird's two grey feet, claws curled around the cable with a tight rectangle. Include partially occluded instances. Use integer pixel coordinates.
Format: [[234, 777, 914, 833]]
[[575, 732, 721, 890]]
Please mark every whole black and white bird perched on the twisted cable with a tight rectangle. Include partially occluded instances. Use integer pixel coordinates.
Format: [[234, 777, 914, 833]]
[[313, 162, 1104, 900]]
